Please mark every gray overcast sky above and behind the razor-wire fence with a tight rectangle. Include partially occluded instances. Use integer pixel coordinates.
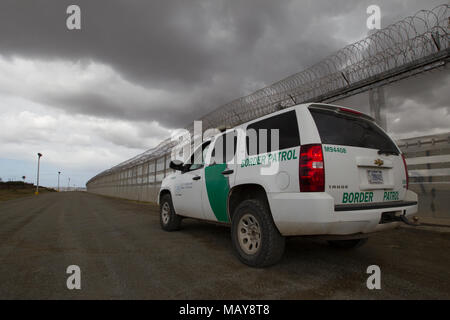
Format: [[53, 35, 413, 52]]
[[0, 0, 450, 185]]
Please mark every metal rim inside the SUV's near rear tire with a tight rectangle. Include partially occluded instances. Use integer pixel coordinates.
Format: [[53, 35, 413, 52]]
[[238, 213, 261, 254]]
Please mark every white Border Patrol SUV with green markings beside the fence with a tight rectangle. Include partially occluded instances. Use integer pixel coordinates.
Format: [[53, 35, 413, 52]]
[[158, 104, 417, 267]]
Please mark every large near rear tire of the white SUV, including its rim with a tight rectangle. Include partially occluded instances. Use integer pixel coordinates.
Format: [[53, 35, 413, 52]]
[[231, 199, 285, 268]]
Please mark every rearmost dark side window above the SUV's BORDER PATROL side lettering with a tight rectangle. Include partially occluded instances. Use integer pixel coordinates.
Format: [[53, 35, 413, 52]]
[[246, 110, 300, 156]]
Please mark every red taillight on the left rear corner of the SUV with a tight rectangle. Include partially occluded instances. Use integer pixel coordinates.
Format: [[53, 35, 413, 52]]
[[298, 144, 325, 192]]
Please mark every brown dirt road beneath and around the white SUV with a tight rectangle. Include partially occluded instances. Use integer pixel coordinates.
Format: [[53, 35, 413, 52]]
[[0, 192, 450, 299]]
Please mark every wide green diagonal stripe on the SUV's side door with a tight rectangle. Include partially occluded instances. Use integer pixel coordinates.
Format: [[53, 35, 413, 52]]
[[205, 163, 230, 222]]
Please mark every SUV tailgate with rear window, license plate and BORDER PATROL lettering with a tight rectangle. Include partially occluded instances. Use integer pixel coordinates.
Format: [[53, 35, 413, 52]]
[[309, 105, 406, 205]]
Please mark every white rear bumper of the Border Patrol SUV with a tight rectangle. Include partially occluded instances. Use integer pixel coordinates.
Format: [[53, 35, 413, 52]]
[[268, 190, 418, 236]]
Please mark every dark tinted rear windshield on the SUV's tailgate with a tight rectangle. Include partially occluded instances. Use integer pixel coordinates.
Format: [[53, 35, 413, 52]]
[[309, 108, 398, 152]]
